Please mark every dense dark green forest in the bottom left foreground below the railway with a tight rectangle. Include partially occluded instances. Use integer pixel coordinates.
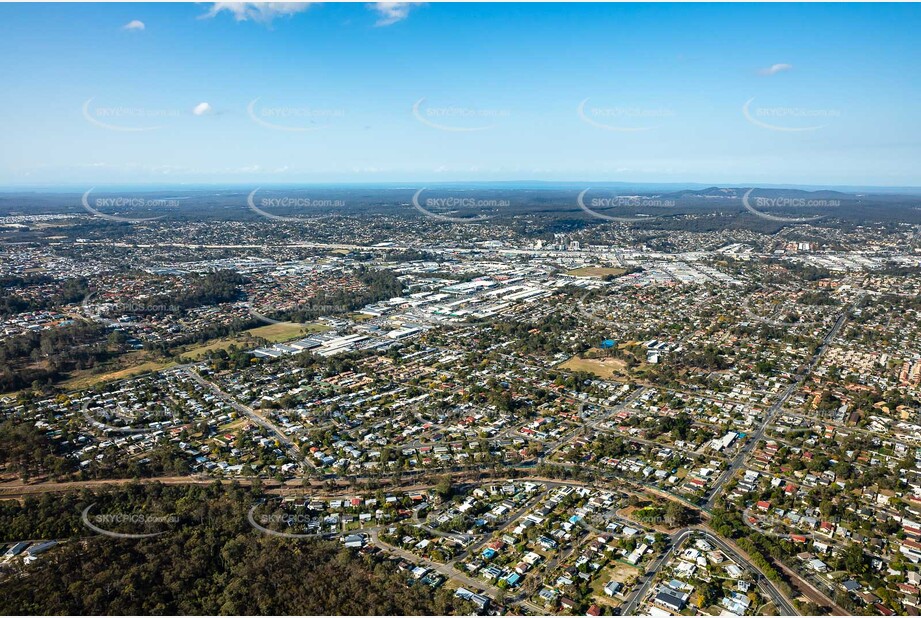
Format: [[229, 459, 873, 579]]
[[0, 482, 470, 615]]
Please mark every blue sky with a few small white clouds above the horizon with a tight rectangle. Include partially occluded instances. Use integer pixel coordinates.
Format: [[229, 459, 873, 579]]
[[0, 3, 921, 187]]
